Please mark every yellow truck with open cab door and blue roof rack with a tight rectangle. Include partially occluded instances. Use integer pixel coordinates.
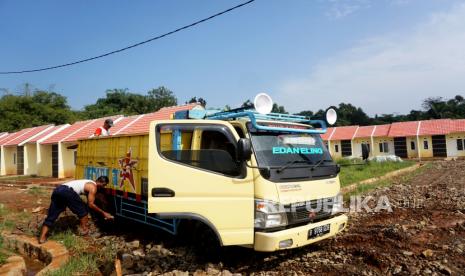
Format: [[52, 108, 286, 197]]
[[76, 97, 347, 252]]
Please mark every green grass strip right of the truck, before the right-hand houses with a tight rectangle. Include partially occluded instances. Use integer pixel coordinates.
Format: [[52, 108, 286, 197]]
[[338, 160, 415, 187]]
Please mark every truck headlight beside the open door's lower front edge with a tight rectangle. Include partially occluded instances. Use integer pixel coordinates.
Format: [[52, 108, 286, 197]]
[[254, 199, 287, 229]]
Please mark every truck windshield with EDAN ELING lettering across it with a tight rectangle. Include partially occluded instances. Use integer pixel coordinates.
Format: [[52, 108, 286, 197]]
[[249, 124, 331, 167]]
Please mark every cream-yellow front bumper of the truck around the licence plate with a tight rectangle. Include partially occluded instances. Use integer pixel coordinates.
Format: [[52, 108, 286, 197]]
[[254, 215, 347, 252]]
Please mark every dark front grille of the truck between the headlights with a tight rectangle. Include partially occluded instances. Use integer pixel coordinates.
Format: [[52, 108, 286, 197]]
[[284, 198, 334, 224]]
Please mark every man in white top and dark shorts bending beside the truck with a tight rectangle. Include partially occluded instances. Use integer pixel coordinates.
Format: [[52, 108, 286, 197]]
[[39, 176, 114, 243]]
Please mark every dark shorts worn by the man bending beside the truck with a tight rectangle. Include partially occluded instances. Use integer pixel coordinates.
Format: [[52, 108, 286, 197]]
[[44, 185, 88, 226]]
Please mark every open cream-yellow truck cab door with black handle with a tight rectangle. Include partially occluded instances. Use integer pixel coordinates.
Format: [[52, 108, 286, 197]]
[[148, 120, 254, 245]]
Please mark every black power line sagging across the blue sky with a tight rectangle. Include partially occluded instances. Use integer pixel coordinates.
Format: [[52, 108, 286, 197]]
[[0, 0, 255, 75]]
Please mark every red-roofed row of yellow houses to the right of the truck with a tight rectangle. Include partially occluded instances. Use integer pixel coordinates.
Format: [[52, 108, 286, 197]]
[[322, 119, 465, 159]]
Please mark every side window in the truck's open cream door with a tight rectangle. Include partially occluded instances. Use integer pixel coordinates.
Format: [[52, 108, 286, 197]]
[[157, 125, 243, 177]]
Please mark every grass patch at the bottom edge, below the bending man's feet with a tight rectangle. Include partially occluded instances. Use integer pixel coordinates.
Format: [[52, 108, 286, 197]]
[[46, 254, 99, 276]]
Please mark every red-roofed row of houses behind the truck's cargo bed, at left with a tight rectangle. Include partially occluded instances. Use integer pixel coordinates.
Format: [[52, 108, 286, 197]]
[[0, 104, 196, 178]]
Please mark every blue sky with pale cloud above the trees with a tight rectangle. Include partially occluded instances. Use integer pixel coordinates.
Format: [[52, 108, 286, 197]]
[[0, 0, 465, 115]]
